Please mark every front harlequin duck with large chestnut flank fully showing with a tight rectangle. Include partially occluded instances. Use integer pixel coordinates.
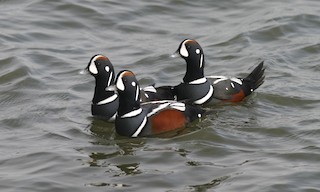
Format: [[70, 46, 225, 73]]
[[115, 70, 204, 137]]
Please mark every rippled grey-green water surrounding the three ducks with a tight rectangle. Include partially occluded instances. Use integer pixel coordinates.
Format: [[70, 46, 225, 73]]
[[0, 0, 320, 192]]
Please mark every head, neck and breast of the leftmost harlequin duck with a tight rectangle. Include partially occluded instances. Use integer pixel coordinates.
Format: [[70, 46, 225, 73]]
[[86, 54, 119, 121]]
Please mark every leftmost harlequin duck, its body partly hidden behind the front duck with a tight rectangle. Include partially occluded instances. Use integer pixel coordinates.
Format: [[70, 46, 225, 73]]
[[85, 54, 174, 121]]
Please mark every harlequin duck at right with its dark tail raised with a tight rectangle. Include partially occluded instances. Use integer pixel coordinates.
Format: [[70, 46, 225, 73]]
[[174, 39, 265, 104]]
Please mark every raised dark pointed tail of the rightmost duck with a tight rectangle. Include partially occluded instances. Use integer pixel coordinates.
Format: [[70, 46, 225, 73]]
[[243, 61, 265, 96]]
